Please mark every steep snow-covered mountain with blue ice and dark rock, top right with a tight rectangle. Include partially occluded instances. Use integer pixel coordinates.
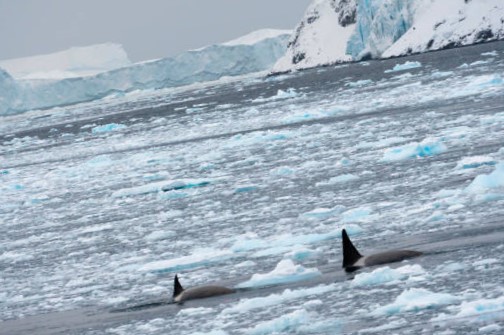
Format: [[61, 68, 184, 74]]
[[272, 0, 504, 72]]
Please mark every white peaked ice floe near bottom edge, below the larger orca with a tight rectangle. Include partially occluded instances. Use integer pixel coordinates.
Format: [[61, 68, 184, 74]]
[[371, 288, 460, 316]]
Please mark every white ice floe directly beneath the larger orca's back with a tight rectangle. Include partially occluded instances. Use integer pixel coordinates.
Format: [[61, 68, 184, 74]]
[[351, 264, 425, 286]]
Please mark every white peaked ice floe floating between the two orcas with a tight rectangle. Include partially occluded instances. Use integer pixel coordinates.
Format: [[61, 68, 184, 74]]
[[237, 259, 321, 288]]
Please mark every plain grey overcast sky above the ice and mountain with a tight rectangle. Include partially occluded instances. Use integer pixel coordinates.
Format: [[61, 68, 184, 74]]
[[0, 0, 311, 61]]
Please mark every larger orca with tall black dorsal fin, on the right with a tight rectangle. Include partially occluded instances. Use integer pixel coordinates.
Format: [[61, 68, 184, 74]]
[[341, 229, 422, 272]]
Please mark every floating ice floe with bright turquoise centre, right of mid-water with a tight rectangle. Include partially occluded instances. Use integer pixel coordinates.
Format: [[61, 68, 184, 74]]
[[381, 138, 447, 162]]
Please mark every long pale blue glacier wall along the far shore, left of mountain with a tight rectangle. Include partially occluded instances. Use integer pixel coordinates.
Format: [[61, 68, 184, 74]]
[[0, 29, 290, 115]]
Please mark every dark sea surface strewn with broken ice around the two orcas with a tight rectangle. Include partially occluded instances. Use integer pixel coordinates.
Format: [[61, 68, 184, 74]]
[[0, 43, 504, 334]]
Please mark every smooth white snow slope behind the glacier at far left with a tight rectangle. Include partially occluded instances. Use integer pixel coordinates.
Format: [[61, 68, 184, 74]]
[[0, 43, 131, 79]]
